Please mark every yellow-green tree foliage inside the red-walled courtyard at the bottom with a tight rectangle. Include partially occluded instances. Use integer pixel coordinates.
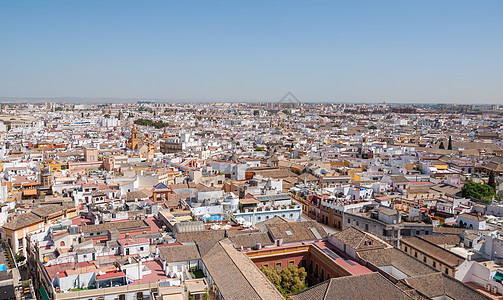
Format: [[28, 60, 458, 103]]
[[260, 266, 307, 298]]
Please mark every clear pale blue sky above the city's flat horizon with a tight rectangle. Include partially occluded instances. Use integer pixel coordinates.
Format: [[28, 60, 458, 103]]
[[0, 0, 503, 104]]
